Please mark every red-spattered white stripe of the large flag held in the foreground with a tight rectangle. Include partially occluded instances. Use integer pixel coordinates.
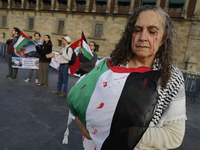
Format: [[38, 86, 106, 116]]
[[86, 70, 129, 150]]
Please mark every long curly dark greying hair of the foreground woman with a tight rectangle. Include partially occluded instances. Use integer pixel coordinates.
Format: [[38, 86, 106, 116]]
[[110, 5, 175, 88]]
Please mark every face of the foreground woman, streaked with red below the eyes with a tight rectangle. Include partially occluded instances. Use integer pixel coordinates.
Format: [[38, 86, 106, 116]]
[[131, 11, 164, 58]]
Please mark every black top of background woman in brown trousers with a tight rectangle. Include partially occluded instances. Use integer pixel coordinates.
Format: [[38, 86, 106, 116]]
[[36, 43, 52, 63]]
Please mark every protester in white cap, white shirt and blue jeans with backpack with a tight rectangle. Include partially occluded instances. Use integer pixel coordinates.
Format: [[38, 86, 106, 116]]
[[51, 36, 73, 97]]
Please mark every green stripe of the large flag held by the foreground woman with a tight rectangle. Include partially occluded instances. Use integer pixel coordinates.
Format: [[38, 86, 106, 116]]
[[67, 59, 109, 127]]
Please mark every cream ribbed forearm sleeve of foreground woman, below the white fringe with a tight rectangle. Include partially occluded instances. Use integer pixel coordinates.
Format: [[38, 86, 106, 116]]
[[137, 120, 185, 149]]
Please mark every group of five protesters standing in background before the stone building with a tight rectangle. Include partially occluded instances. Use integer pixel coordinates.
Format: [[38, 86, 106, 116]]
[[4, 27, 98, 97]]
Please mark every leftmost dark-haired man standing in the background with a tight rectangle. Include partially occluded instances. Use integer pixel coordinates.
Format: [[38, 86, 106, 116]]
[[4, 27, 20, 81]]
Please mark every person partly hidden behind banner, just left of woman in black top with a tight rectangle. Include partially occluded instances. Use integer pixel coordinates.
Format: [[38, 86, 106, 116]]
[[25, 32, 41, 84]]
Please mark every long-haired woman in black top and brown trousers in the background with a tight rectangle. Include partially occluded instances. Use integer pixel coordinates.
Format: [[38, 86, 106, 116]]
[[35, 34, 53, 87]]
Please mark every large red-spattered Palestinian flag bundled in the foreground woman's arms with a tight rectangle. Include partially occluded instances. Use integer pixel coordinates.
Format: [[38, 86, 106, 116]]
[[67, 59, 160, 150]]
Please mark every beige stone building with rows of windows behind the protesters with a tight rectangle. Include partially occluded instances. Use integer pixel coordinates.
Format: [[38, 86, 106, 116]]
[[0, 0, 200, 72]]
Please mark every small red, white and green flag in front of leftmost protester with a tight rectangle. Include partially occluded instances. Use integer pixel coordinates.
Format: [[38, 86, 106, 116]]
[[14, 31, 31, 50]]
